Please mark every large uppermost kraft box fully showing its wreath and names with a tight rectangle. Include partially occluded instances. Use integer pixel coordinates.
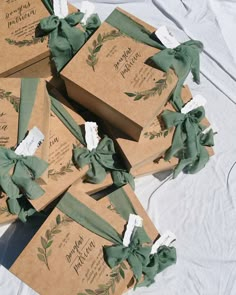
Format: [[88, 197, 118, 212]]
[[61, 9, 177, 140]]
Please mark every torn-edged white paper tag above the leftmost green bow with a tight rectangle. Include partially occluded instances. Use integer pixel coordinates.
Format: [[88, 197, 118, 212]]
[[15, 127, 44, 156]]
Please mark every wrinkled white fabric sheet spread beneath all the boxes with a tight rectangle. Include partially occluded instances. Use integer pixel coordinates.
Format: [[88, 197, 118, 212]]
[[0, 0, 236, 295]]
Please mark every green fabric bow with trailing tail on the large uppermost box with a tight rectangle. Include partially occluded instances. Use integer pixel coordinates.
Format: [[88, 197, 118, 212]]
[[150, 40, 203, 111]]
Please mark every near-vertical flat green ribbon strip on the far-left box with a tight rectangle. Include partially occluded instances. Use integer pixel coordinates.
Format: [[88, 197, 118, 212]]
[[17, 78, 39, 144]]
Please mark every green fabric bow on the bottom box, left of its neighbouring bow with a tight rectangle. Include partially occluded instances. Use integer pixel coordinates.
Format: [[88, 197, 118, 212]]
[[103, 230, 151, 281]]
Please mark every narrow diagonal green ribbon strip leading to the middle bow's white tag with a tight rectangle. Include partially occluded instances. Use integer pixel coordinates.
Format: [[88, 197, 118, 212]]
[[49, 95, 86, 146]]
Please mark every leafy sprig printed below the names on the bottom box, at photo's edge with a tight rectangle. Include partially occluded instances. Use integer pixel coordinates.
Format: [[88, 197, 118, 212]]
[[77, 262, 127, 295]]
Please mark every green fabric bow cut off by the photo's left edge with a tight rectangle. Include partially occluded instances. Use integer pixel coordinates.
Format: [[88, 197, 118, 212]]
[[0, 147, 48, 215]]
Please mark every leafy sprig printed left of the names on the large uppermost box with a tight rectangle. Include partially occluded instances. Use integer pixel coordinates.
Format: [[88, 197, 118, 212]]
[[86, 30, 124, 71]]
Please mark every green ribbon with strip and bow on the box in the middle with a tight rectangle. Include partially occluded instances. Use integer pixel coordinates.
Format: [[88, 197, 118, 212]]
[[50, 95, 134, 189]]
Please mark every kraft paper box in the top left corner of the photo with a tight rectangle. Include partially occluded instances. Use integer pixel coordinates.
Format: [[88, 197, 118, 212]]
[[0, 0, 76, 77]]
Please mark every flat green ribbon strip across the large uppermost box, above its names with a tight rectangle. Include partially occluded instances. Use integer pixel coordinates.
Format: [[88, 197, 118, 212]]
[[105, 9, 166, 50]]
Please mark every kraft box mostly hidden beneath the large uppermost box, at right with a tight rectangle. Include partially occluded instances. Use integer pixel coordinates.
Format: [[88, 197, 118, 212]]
[[104, 86, 209, 173]]
